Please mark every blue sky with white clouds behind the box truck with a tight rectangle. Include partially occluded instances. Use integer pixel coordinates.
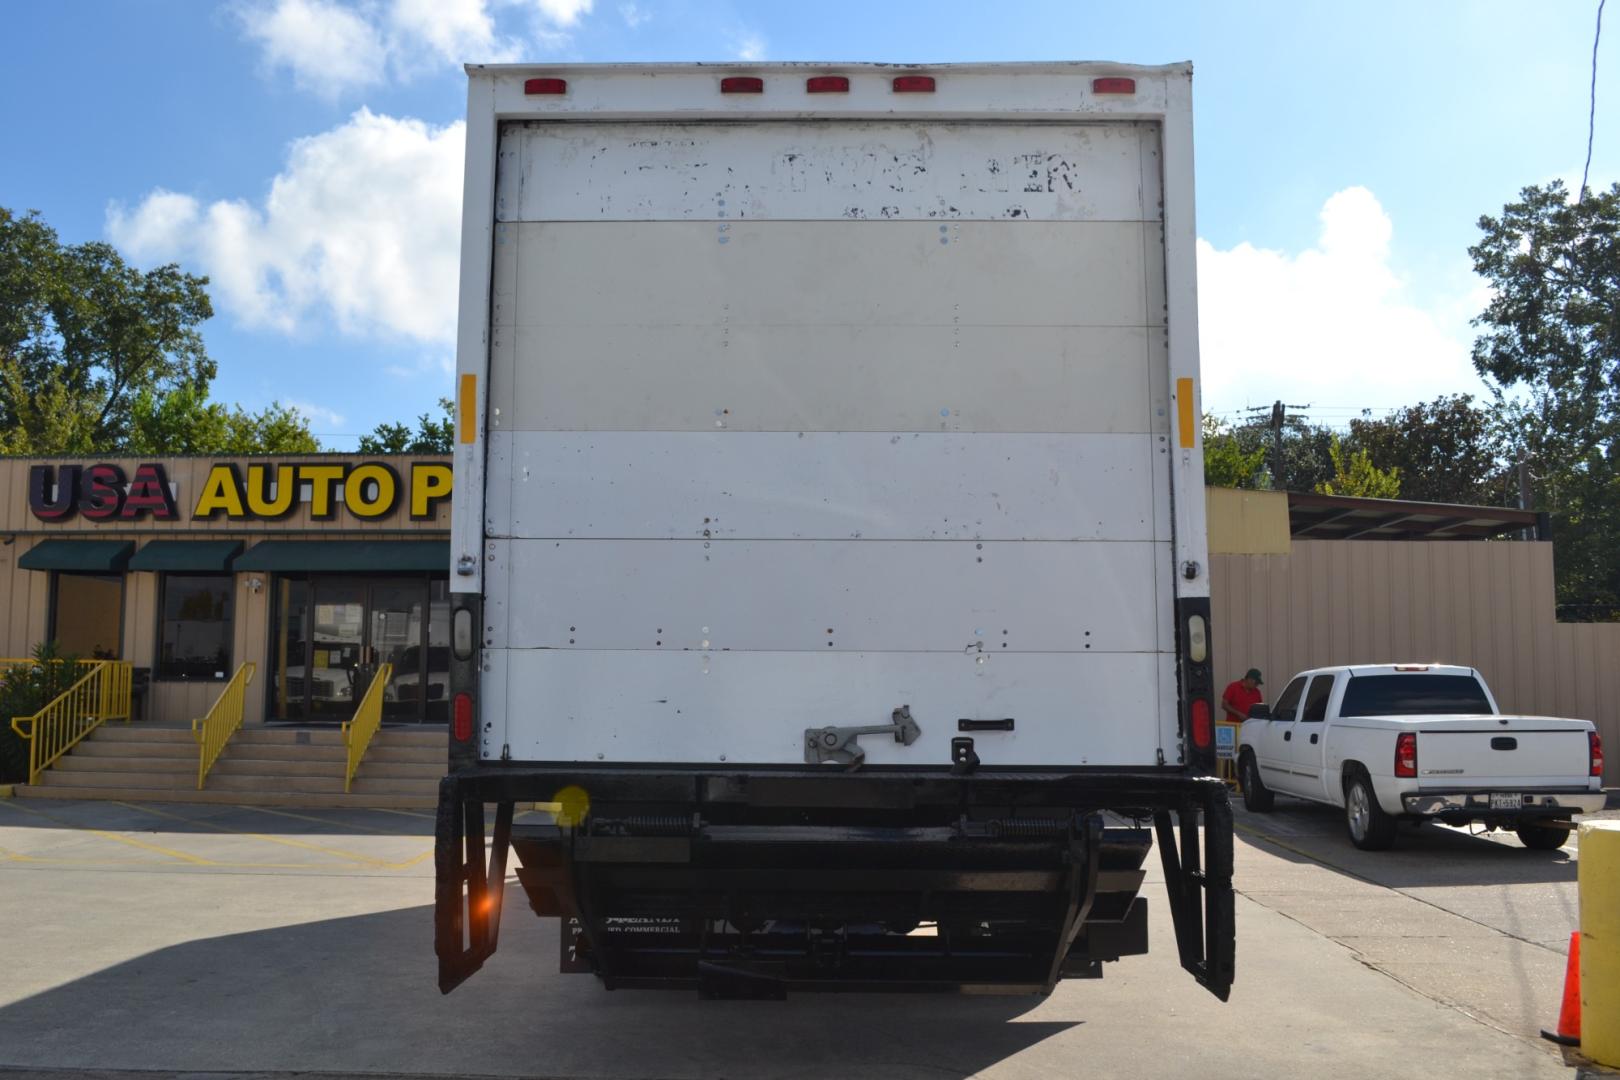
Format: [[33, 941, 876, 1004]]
[[0, 0, 1620, 449]]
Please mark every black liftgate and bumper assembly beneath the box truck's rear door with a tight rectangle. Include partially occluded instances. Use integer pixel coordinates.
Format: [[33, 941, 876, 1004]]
[[434, 763, 1234, 1001]]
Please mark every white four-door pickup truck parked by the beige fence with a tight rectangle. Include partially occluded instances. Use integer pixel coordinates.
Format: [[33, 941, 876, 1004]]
[[1238, 664, 1604, 850]]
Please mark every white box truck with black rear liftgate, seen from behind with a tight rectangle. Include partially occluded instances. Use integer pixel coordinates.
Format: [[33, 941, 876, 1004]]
[[436, 63, 1233, 999]]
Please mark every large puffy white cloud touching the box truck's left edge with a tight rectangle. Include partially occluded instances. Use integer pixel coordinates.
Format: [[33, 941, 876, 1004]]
[[107, 108, 465, 345]]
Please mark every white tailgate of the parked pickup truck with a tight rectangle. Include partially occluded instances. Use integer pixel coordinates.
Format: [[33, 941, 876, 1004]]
[[1418, 716, 1591, 790]]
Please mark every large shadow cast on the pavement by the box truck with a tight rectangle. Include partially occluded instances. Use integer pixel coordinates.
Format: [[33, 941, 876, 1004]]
[[0, 887, 1076, 1080]]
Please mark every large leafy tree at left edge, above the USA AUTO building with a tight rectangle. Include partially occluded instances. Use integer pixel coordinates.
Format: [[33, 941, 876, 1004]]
[[0, 207, 215, 453]]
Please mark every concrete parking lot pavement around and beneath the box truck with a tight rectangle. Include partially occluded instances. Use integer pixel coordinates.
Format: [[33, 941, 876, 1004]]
[[0, 800, 1600, 1080]]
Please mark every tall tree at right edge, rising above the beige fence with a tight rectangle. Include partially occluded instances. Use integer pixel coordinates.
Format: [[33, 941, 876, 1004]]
[[1468, 181, 1620, 606]]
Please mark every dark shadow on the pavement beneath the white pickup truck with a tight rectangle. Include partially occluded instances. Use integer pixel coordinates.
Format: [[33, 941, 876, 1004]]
[[1234, 798, 1578, 889]]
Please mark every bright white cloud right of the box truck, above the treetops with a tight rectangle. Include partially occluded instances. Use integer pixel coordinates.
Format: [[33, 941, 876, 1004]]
[[1197, 188, 1482, 423]]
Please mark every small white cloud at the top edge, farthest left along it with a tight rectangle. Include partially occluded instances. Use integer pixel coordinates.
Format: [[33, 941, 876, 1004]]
[[238, 0, 387, 97]]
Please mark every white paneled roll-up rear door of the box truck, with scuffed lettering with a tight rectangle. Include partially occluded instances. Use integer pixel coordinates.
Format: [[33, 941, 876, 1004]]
[[481, 118, 1179, 766]]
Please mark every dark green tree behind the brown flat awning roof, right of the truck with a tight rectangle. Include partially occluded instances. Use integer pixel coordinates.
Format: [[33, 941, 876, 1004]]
[[1345, 393, 1518, 507]]
